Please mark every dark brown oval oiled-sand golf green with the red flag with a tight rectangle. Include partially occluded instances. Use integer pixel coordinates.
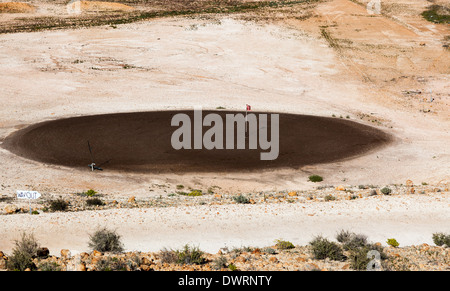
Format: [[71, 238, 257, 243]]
[[2, 111, 391, 173]]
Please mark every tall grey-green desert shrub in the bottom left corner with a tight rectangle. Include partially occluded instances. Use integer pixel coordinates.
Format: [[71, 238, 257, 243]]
[[7, 233, 39, 271]]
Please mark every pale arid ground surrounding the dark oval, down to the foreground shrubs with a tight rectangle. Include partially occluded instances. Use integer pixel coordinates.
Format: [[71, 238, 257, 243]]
[[0, 0, 450, 272]]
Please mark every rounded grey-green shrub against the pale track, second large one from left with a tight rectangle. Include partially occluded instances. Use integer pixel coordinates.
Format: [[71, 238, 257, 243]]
[[89, 228, 123, 253]]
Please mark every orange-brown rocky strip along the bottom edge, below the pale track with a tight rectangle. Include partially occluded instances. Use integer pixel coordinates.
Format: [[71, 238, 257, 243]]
[[0, 243, 450, 271]]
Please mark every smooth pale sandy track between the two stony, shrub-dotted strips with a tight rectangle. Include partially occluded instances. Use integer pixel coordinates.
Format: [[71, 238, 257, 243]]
[[0, 192, 450, 255]]
